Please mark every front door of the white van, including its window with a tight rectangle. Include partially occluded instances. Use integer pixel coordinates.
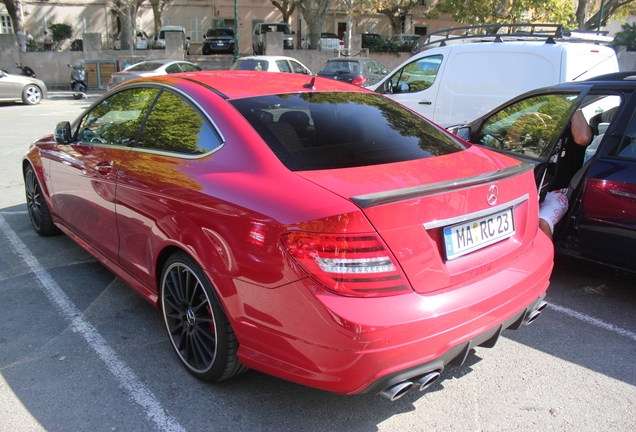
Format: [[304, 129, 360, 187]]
[[376, 54, 444, 119]]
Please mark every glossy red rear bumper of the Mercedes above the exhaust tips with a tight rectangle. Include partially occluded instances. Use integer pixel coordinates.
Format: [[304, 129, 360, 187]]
[[233, 233, 553, 395]]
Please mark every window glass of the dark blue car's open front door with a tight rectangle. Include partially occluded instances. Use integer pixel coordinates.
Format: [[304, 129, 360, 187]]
[[477, 94, 578, 160]]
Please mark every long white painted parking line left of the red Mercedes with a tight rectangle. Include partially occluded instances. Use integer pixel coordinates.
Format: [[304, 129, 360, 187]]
[[0, 215, 185, 431]]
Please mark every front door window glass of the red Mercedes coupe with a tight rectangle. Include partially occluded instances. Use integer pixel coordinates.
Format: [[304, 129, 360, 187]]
[[77, 88, 159, 146]]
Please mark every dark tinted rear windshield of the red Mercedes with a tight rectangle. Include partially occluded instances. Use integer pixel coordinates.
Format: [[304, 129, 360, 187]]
[[230, 92, 464, 171]]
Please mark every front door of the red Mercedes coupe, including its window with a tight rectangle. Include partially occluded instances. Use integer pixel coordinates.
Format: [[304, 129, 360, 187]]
[[49, 89, 157, 262]]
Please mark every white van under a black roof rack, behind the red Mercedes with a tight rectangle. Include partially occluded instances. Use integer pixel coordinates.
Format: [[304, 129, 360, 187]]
[[370, 25, 618, 127]]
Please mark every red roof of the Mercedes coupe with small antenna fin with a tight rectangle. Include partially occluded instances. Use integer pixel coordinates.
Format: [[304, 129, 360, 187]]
[[140, 70, 369, 99]]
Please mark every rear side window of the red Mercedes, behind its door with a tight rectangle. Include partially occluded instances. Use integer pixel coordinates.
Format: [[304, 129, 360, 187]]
[[137, 91, 221, 154]]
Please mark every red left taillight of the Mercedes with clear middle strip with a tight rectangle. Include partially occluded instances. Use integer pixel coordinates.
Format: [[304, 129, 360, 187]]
[[282, 232, 410, 297]]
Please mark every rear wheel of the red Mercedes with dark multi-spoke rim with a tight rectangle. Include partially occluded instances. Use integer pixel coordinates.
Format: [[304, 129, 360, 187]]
[[160, 252, 247, 382]]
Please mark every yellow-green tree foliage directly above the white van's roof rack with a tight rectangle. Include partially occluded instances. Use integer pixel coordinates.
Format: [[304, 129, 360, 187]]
[[426, 0, 574, 25]]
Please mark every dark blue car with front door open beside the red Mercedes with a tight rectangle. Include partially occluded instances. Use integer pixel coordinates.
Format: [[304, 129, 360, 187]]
[[453, 71, 636, 271]]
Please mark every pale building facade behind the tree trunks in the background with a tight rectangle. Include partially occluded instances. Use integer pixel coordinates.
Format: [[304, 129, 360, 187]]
[[0, 0, 456, 54]]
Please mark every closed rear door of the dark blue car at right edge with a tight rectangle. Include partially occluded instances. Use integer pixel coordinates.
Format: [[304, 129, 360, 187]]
[[578, 97, 636, 271]]
